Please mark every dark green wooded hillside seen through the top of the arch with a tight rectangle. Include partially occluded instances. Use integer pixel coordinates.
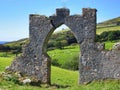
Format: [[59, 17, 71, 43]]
[[47, 31, 77, 49]]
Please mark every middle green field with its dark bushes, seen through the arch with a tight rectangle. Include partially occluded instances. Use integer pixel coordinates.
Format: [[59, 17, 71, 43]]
[[48, 44, 80, 70]]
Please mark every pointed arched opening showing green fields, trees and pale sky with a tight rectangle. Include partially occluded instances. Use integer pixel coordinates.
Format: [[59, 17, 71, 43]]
[[47, 24, 80, 85]]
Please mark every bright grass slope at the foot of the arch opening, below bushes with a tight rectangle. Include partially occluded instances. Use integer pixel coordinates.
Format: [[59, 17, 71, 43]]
[[51, 66, 78, 86]]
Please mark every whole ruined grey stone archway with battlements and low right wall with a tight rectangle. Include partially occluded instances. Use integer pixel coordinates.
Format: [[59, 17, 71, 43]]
[[8, 8, 120, 84]]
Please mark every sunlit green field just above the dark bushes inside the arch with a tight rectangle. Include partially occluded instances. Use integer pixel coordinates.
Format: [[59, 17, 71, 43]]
[[48, 45, 80, 69]]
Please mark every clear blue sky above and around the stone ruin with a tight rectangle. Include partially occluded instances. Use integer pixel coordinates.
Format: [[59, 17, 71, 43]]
[[0, 0, 120, 41]]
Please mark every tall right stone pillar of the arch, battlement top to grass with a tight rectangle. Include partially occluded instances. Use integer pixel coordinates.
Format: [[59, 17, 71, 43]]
[[80, 8, 96, 83]]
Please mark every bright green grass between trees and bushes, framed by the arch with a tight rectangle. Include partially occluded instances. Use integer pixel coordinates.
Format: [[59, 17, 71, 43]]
[[48, 45, 80, 64]]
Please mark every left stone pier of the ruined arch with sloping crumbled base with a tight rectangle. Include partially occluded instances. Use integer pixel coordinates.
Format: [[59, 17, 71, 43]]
[[8, 15, 53, 84]]
